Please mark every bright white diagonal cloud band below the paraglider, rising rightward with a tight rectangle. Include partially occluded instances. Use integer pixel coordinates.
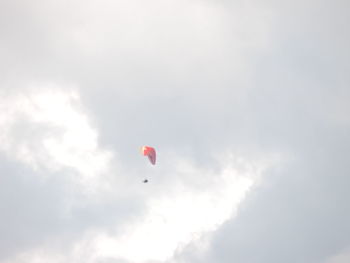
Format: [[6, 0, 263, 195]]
[[3, 146, 278, 263]]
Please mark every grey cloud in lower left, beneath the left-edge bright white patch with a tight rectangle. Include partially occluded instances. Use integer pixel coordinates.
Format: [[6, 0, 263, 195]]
[[0, 155, 142, 262]]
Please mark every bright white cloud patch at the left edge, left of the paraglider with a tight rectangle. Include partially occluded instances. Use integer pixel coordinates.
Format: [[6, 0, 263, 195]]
[[0, 84, 112, 189]]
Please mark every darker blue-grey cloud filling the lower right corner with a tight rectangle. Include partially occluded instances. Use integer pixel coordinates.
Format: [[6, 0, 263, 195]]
[[208, 142, 350, 262]]
